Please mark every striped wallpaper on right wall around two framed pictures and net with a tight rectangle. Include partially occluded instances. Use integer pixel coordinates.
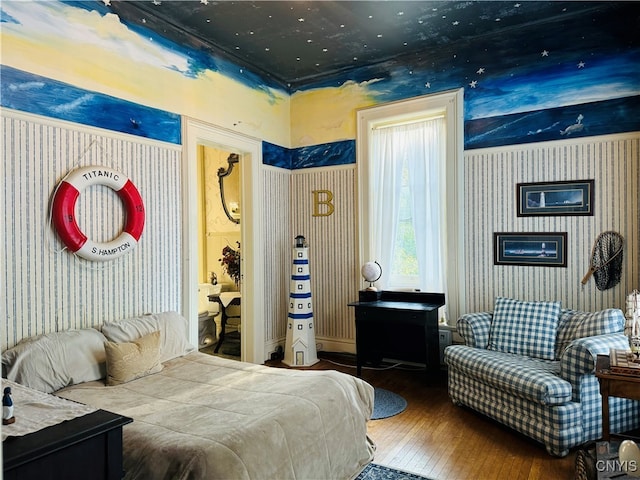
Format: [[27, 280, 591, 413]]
[[464, 133, 640, 311]]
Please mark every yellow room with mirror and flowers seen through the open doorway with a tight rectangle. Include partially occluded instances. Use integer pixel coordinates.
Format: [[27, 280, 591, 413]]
[[198, 145, 242, 360]]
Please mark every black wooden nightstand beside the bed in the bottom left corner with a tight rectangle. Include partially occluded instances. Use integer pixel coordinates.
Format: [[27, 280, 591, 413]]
[[2, 410, 133, 480]]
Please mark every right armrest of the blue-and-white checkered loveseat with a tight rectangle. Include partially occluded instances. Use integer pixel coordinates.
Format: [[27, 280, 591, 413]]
[[560, 333, 629, 388]]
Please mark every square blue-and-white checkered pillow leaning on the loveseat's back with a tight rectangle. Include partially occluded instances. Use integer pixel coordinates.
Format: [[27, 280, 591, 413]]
[[487, 297, 560, 360]]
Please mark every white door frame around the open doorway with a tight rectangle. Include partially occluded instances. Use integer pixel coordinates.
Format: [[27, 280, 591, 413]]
[[182, 117, 265, 363]]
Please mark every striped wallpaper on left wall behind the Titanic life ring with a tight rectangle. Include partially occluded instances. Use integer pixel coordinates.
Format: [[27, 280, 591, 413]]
[[0, 109, 182, 349]]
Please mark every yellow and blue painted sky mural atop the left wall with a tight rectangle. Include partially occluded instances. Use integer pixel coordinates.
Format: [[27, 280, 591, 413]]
[[0, 0, 290, 146]]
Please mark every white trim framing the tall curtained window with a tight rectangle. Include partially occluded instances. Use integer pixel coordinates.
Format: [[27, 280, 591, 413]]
[[356, 89, 466, 324]]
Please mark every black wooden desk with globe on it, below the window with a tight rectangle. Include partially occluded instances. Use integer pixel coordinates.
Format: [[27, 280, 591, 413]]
[[349, 291, 445, 376]]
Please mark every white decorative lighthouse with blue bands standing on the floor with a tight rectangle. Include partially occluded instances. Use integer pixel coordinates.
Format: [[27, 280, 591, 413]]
[[283, 235, 318, 367]]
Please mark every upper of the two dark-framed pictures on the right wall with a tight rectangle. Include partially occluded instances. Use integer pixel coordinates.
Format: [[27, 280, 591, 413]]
[[516, 180, 594, 217]]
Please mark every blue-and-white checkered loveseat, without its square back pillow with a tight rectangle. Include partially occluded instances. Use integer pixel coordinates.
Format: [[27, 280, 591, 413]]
[[445, 310, 640, 456]]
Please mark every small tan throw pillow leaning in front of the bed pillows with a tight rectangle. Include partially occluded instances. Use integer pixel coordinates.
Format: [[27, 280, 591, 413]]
[[104, 331, 162, 386]]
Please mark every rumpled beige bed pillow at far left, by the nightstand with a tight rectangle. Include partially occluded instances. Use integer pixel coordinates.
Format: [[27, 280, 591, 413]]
[[2, 328, 106, 393]]
